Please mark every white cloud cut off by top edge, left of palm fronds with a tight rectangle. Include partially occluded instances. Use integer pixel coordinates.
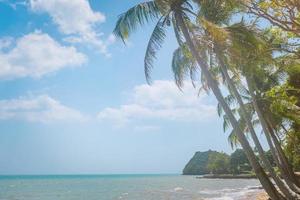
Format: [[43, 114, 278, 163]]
[[29, 0, 112, 55]]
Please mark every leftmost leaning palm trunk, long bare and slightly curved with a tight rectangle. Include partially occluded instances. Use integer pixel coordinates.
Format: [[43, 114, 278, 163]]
[[175, 13, 283, 200]]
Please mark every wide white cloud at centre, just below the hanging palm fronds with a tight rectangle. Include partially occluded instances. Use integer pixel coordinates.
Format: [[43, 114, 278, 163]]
[[98, 81, 216, 125]]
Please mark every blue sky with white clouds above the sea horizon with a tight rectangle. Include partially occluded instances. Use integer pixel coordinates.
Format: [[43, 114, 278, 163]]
[[0, 0, 266, 174]]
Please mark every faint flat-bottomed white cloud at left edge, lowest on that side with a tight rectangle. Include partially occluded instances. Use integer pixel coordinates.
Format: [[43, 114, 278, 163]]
[[0, 95, 87, 123]]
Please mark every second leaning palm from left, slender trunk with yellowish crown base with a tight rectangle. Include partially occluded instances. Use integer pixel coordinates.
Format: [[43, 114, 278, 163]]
[[188, 0, 297, 198]]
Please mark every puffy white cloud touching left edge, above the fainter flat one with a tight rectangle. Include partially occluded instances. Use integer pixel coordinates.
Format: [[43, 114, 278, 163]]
[[0, 31, 87, 79]]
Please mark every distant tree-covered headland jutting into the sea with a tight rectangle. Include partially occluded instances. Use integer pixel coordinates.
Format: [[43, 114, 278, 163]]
[[183, 149, 251, 175]]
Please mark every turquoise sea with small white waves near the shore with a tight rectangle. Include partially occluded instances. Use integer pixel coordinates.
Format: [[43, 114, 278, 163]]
[[0, 174, 261, 200]]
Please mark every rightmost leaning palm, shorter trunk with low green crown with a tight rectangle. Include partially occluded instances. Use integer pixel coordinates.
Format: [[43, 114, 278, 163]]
[[246, 55, 300, 191]]
